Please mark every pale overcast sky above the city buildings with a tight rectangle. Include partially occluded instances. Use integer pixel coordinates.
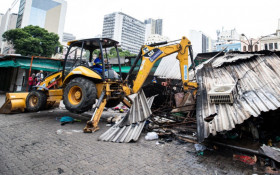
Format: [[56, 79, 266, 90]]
[[0, 0, 280, 39]]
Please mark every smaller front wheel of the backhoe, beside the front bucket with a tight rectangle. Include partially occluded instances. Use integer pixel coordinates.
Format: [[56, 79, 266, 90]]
[[25, 91, 47, 112]]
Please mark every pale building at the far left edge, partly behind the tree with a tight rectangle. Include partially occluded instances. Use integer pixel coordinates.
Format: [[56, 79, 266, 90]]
[[0, 9, 18, 54]]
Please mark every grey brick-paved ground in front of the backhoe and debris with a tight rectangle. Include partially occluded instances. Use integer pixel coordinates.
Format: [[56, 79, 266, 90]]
[[0, 104, 258, 175]]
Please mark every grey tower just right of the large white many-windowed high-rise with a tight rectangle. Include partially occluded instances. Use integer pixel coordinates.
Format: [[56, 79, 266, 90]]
[[144, 18, 162, 41]]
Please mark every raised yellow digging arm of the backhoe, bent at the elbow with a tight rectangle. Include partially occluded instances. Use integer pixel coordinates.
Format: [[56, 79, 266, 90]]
[[132, 37, 197, 93]]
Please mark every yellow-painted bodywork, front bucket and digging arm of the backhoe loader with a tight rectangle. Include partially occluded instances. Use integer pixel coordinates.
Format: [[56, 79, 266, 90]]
[[0, 37, 198, 135]]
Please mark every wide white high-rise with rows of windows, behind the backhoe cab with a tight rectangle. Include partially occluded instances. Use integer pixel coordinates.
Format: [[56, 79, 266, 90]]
[[102, 12, 145, 54]]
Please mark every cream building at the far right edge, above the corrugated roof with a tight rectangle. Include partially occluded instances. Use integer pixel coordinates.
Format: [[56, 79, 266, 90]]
[[260, 19, 280, 51]]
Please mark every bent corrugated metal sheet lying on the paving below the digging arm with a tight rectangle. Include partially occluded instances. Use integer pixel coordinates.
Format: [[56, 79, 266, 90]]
[[99, 90, 155, 143]]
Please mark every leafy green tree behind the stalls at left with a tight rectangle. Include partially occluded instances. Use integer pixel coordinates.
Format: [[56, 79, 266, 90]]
[[2, 25, 62, 57]]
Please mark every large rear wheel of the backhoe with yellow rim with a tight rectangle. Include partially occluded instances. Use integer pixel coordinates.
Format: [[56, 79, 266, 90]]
[[63, 77, 97, 114]]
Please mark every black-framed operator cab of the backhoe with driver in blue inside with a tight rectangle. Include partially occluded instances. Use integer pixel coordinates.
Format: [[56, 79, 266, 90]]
[[63, 38, 121, 80]]
